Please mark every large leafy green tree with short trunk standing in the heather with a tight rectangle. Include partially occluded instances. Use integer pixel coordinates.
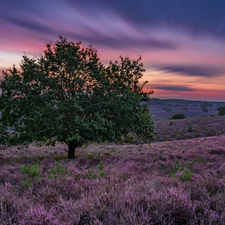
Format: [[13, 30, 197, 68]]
[[0, 37, 153, 159]]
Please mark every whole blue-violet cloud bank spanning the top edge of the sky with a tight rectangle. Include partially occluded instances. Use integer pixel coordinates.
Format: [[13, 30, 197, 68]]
[[0, 0, 225, 50]]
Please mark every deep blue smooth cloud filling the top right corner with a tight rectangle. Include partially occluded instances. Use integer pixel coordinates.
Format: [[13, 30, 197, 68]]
[[64, 0, 225, 40]]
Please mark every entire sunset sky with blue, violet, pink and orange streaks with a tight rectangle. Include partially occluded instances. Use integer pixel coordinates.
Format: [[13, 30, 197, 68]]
[[0, 0, 225, 101]]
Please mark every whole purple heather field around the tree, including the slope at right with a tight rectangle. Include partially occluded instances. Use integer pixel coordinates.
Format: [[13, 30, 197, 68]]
[[0, 116, 225, 225]]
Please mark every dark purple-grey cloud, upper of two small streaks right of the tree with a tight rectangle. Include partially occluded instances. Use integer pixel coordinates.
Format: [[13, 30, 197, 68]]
[[153, 64, 225, 77]]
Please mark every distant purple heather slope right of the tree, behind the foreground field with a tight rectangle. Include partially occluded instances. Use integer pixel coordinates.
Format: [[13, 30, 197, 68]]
[[155, 116, 225, 141]]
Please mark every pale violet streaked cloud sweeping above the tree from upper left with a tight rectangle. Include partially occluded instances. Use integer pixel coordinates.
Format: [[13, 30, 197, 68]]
[[0, 0, 178, 50]]
